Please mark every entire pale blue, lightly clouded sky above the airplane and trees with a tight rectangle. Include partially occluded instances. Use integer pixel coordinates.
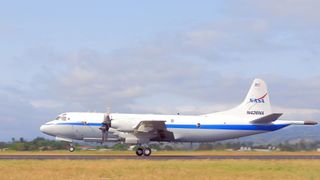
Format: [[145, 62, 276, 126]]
[[0, 0, 320, 141]]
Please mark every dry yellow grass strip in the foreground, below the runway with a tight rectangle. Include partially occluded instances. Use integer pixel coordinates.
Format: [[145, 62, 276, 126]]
[[0, 160, 320, 180]]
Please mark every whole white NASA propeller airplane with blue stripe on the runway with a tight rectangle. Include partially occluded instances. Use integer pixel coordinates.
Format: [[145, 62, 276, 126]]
[[40, 79, 317, 156]]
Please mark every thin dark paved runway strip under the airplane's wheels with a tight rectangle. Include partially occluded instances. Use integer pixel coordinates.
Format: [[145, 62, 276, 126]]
[[0, 155, 320, 160]]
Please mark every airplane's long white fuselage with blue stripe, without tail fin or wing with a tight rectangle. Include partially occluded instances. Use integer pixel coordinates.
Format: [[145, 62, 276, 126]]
[[42, 112, 290, 142]]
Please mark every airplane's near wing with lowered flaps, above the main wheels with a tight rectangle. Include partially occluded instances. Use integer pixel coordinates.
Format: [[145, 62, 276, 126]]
[[134, 120, 174, 141]]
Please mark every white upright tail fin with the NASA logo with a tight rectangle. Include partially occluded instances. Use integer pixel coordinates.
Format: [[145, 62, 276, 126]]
[[216, 79, 272, 119]]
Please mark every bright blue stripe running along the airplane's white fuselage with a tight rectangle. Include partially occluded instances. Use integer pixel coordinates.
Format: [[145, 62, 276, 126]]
[[47, 122, 290, 131]]
